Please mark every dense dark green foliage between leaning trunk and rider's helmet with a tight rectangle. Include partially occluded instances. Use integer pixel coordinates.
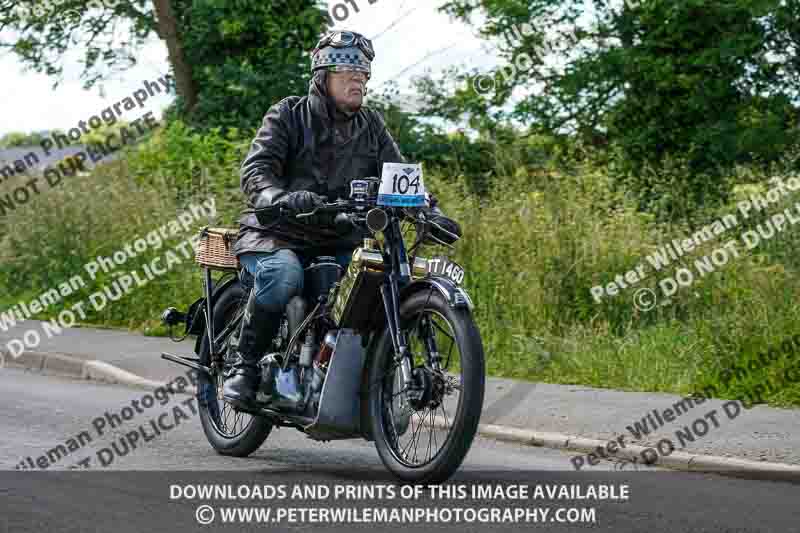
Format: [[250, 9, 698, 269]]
[[166, 0, 325, 128]]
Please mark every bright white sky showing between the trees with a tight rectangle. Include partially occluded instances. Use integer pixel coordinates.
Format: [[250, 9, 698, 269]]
[[0, 0, 499, 135]]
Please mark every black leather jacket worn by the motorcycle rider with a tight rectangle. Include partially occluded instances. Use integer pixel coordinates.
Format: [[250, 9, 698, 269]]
[[233, 71, 405, 255]]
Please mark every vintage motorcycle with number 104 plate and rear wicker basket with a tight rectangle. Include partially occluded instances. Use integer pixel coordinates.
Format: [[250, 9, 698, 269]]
[[162, 163, 485, 483]]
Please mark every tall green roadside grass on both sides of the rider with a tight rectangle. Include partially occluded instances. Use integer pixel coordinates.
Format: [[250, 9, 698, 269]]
[[0, 123, 800, 406]]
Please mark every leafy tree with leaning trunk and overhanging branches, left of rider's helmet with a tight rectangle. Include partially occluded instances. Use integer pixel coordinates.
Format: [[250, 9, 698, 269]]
[[0, 0, 325, 128]]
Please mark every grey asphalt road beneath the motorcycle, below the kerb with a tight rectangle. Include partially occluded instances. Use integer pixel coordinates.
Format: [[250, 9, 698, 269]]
[[0, 369, 800, 533]]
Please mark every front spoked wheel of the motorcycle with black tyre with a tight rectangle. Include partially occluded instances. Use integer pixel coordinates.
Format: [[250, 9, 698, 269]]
[[370, 291, 485, 483]]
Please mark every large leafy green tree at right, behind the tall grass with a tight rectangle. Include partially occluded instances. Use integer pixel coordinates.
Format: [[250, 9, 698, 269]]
[[418, 0, 800, 213]]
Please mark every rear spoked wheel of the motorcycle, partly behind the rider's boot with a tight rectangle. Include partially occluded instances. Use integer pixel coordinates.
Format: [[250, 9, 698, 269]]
[[197, 283, 272, 457]]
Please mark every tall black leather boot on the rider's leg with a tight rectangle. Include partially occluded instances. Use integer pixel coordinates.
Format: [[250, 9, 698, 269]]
[[222, 291, 281, 411]]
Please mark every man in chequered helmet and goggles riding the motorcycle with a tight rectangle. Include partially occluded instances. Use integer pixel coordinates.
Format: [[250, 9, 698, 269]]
[[223, 31, 461, 409]]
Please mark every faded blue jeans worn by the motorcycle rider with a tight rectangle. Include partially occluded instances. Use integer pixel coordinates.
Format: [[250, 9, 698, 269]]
[[239, 249, 353, 313]]
